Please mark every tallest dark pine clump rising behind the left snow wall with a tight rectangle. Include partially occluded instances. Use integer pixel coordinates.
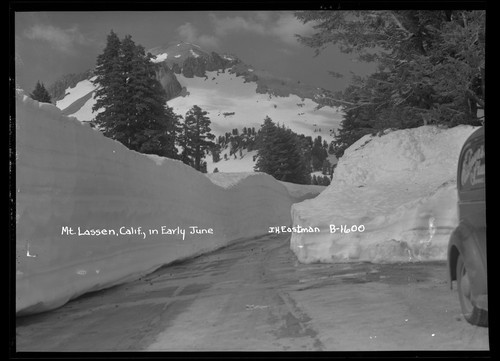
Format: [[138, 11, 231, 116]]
[[93, 31, 180, 158]]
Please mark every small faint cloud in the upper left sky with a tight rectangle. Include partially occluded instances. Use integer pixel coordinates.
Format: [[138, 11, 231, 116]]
[[24, 25, 90, 54]]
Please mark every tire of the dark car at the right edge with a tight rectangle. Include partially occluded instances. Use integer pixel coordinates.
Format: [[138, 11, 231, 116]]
[[457, 255, 488, 327]]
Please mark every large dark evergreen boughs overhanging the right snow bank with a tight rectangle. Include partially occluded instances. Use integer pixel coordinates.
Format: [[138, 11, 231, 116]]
[[295, 10, 486, 153]]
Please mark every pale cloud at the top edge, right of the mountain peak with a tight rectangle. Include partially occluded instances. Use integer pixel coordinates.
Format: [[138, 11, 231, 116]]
[[210, 11, 313, 45]]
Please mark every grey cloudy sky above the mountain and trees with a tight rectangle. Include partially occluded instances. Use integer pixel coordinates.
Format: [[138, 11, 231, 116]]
[[15, 11, 374, 91]]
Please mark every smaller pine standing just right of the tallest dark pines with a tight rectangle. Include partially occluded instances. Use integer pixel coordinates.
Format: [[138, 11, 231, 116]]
[[180, 105, 215, 170]]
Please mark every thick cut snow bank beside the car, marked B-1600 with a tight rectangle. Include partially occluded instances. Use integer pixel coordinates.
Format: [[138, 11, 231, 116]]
[[291, 126, 476, 263]]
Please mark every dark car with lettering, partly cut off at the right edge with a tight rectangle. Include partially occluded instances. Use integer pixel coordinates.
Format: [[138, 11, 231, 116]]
[[448, 127, 488, 326]]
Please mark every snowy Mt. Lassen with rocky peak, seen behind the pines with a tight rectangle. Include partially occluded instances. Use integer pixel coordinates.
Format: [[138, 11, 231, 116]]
[[48, 42, 342, 172]]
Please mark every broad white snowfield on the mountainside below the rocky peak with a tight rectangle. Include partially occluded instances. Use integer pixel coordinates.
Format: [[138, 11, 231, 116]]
[[168, 70, 342, 143]]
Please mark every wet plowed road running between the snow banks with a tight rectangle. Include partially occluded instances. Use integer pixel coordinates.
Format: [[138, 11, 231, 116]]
[[16, 235, 489, 351]]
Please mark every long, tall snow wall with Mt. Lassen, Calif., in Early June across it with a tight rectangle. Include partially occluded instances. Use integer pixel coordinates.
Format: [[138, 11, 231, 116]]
[[16, 93, 292, 314]]
